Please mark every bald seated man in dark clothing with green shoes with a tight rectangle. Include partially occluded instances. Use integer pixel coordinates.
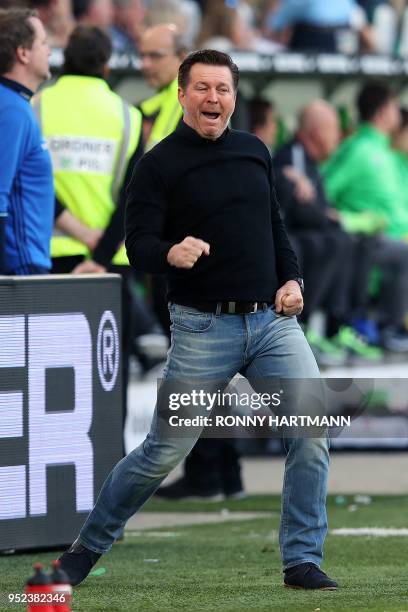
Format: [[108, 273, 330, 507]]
[[274, 100, 382, 365]]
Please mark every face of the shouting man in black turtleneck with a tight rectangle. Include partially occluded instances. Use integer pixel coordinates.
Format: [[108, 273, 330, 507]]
[[179, 64, 236, 140]]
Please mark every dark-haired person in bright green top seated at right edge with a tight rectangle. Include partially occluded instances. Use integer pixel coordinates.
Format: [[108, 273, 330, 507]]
[[324, 83, 408, 351]]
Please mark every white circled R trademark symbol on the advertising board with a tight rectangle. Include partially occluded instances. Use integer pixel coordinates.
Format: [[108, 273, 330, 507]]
[[96, 310, 120, 391]]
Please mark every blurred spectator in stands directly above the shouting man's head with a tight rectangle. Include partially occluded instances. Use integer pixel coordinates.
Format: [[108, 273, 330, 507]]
[[198, 0, 281, 53]]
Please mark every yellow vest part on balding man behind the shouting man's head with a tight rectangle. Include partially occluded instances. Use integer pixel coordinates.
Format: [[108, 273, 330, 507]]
[[139, 78, 183, 151]]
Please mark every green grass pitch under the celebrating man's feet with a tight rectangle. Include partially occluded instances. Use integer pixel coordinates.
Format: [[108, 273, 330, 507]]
[[0, 496, 408, 612]]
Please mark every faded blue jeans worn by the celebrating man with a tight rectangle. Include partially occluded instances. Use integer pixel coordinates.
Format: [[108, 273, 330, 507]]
[[79, 304, 329, 569]]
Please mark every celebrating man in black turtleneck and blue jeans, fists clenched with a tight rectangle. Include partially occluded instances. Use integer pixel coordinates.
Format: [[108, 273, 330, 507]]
[[61, 50, 337, 589]]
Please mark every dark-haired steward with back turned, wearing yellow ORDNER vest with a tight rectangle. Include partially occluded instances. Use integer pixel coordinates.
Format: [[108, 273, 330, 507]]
[[34, 26, 143, 430]]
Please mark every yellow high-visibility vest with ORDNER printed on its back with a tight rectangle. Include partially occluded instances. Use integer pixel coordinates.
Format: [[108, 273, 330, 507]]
[[34, 75, 142, 265]]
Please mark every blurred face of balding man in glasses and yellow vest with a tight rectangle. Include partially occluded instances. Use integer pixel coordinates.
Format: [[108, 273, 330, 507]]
[[139, 33, 180, 89]]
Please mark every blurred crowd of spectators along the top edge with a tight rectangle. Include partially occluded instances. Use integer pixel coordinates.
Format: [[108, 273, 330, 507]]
[[0, 0, 408, 56]]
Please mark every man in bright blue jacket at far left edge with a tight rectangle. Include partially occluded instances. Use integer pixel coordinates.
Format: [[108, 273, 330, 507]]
[[0, 9, 54, 275]]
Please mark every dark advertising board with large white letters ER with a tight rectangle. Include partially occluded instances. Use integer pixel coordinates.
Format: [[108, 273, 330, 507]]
[[0, 275, 122, 550]]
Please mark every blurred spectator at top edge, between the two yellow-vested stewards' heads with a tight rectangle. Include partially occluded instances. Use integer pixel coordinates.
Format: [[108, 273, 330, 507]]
[[109, 0, 145, 53]]
